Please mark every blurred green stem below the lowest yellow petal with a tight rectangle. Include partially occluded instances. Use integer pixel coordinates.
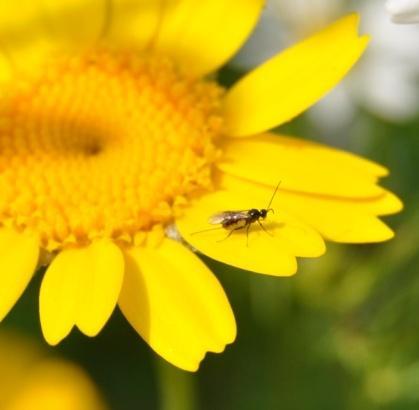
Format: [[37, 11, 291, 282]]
[[156, 358, 198, 410]]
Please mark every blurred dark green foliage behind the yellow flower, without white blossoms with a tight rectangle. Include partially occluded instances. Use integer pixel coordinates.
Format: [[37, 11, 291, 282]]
[[2, 0, 419, 410]]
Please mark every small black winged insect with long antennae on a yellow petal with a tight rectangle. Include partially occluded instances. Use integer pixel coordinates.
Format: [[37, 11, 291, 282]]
[[195, 181, 281, 245]]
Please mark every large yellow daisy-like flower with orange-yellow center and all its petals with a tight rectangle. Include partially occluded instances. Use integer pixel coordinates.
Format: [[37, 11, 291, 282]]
[[0, 0, 401, 370]]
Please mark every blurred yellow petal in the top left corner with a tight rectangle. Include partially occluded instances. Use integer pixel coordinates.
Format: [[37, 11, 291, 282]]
[[0, 0, 107, 75]]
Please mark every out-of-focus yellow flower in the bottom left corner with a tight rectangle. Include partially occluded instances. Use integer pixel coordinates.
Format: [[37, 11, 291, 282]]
[[0, 332, 106, 410]]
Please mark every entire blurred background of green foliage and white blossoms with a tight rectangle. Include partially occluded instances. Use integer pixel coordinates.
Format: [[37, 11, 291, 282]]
[[0, 0, 419, 410]]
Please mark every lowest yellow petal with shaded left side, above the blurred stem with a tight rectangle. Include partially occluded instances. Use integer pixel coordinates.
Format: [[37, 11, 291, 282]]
[[119, 239, 236, 371]]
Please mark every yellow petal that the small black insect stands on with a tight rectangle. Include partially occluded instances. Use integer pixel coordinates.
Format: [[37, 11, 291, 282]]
[[176, 191, 325, 276]]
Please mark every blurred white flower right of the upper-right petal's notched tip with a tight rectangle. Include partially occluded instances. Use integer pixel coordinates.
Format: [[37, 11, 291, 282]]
[[356, 0, 419, 121]]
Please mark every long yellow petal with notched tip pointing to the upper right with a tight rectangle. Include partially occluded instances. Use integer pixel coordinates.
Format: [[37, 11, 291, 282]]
[[225, 14, 368, 136]]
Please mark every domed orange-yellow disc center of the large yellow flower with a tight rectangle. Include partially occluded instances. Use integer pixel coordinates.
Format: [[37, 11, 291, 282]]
[[0, 52, 222, 249]]
